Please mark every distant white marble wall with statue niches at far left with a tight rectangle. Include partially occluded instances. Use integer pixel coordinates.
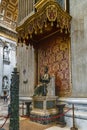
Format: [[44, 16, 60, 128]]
[[0, 36, 16, 96]]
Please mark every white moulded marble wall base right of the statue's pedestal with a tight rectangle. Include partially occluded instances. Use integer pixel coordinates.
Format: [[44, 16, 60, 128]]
[[59, 98, 87, 130]]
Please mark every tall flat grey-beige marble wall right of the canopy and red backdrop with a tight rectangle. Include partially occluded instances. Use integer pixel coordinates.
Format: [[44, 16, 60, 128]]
[[70, 0, 87, 97]]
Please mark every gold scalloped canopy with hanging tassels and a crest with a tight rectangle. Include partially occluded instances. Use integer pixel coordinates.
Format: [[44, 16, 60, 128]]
[[16, 0, 71, 43]]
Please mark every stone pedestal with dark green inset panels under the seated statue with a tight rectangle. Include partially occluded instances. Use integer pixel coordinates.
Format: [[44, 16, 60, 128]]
[[30, 96, 58, 124]]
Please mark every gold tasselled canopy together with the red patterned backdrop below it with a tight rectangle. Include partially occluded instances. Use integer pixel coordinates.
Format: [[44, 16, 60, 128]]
[[16, 0, 71, 96]]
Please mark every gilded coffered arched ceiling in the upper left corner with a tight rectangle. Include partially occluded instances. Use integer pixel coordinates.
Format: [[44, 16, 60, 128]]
[[0, 0, 18, 29]]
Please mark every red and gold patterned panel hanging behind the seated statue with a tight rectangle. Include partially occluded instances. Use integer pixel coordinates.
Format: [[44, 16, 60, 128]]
[[38, 35, 71, 96]]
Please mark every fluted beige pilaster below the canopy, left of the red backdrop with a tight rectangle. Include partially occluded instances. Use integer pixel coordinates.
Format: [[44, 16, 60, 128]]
[[17, 44, 36, 97]]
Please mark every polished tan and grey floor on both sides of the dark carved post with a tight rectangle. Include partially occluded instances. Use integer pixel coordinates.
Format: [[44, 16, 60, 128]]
[[0, 99, 70, 130]]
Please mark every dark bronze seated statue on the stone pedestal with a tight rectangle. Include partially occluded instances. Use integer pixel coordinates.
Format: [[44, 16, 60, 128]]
[[34, 66, 50, 96]]
